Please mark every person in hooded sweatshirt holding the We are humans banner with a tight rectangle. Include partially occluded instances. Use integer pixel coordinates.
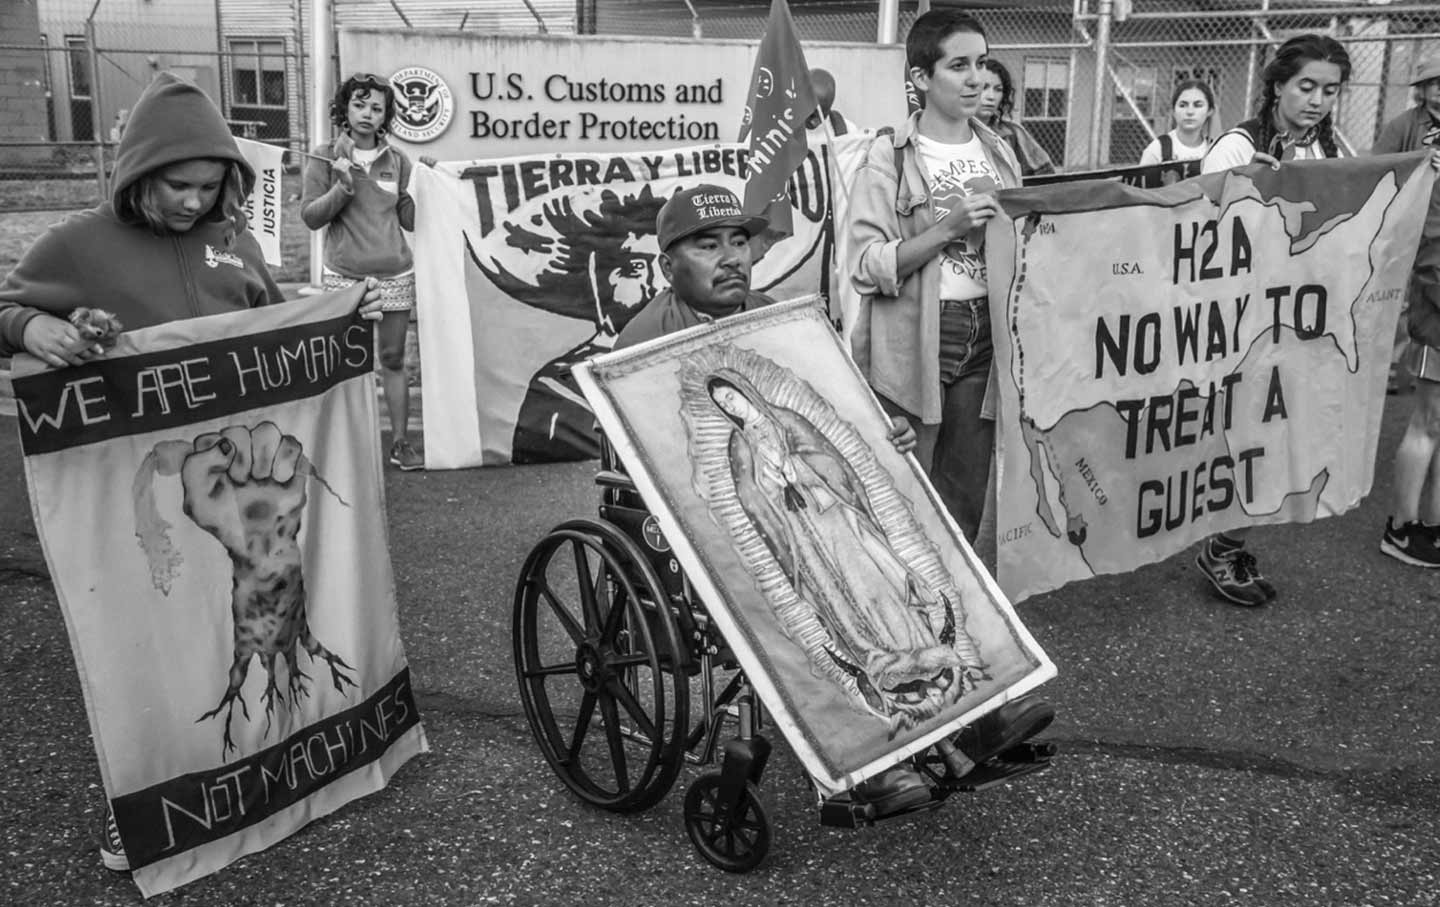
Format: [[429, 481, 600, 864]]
[[0, 72, 380, 871]]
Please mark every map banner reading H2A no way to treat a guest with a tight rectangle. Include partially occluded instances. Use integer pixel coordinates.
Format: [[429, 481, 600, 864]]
[[985, 154, 1434, 599]]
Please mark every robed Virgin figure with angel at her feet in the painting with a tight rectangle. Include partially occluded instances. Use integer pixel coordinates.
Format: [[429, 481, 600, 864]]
[[706, 369, 981, 734]]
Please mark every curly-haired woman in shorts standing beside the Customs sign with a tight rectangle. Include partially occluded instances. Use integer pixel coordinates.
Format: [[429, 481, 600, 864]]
[[300, 73, 425, 469]]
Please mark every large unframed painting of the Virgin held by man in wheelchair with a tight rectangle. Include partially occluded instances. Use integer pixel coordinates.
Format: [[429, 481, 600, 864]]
[[576, 299, 1056, 793]]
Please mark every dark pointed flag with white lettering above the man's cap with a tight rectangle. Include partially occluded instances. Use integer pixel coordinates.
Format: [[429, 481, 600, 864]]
[[740, 0, 818, 244]]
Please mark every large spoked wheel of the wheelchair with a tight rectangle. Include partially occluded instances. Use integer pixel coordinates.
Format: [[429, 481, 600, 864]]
[[513, 520, 690, 812]]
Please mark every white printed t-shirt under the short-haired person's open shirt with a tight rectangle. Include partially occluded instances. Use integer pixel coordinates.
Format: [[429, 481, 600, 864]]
[[914, 135, 999, 299]]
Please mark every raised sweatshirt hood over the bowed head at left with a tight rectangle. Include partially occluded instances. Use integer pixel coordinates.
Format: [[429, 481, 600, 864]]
[[111, 72, 255, 207]]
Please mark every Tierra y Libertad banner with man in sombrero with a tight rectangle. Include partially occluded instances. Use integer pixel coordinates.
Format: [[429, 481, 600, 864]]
[[415, 140, 867, 469]]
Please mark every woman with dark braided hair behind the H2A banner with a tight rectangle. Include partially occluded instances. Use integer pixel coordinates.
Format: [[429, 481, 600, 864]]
[[1195, 35, 1351, 608]]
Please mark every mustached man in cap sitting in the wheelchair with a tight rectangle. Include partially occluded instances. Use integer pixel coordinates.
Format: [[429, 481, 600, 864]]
[[615, 186, 1054, 818]]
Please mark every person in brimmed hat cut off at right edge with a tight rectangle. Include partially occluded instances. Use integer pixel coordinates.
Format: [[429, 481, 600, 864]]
[[1372, 55, 1440, 569]]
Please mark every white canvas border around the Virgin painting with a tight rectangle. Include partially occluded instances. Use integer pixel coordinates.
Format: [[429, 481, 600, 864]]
[[575, 297, 1056, 795]]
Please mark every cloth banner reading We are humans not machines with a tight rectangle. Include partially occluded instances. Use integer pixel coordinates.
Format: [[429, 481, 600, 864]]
[[14, 288, 428, 897]]
